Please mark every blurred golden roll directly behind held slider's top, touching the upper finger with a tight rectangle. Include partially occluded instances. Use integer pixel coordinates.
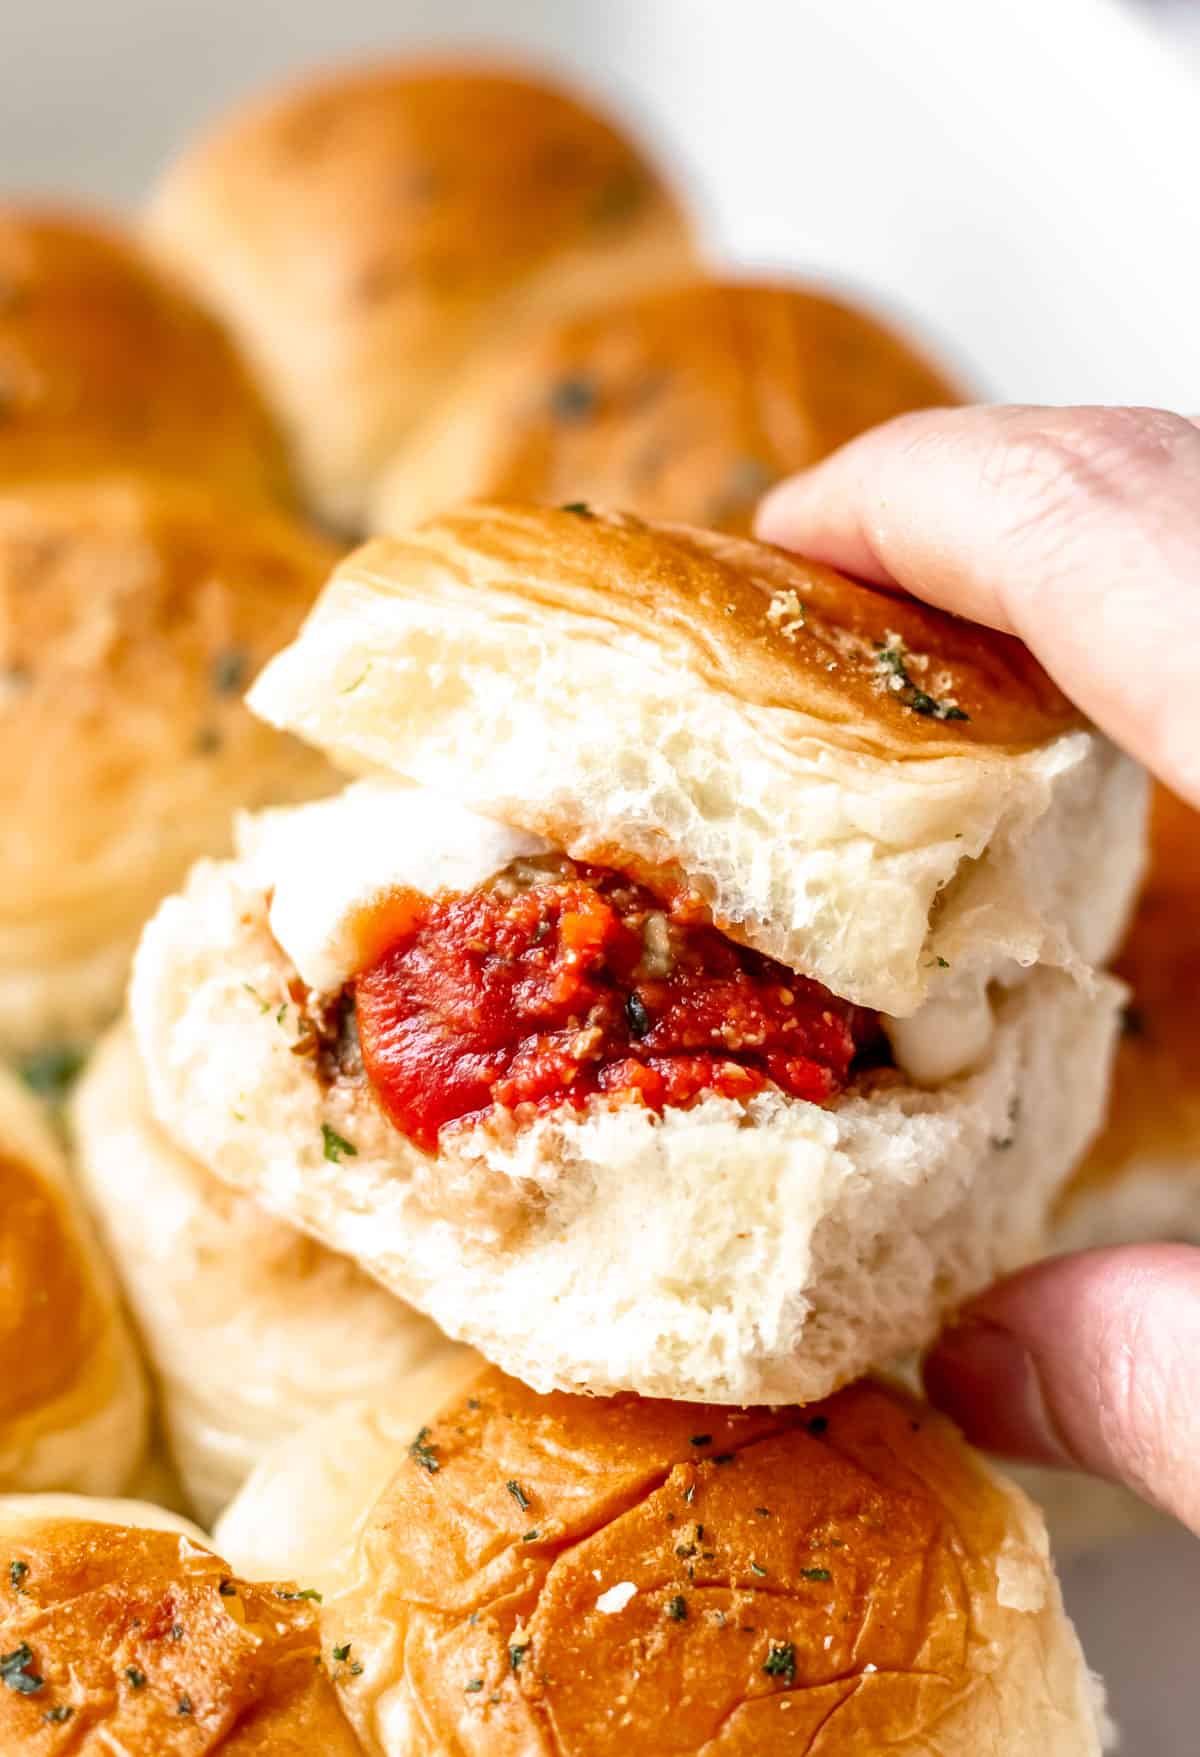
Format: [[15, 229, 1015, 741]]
[[371, 279, 961, 532]]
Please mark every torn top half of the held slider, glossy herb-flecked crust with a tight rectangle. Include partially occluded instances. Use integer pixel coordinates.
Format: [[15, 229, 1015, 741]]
[[249, 504, 1142, 1017]]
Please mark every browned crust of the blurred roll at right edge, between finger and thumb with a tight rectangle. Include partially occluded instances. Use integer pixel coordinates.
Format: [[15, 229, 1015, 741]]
[[1066, 787, 1200, 1204]]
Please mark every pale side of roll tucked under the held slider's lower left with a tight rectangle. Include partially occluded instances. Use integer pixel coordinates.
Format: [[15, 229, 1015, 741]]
[[72, 1028, 462, 1523]]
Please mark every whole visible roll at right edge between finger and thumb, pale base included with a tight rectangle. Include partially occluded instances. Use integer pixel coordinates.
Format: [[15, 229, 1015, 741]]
[[1056, 787, 1200, 1251]]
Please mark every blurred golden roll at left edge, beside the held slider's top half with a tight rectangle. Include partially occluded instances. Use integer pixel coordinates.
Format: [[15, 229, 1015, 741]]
[[0, 478, 334, 1051]]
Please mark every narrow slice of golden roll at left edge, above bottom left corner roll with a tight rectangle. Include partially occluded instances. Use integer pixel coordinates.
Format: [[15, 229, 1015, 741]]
[[0, 1068, 146, 1495]]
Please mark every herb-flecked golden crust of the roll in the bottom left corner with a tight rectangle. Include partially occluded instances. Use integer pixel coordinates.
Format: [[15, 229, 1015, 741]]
[[0, 1518, 360, 1757]]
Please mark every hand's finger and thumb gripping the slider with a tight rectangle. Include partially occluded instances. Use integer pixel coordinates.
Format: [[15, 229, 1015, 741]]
[[757, 408, 1200, 1532]]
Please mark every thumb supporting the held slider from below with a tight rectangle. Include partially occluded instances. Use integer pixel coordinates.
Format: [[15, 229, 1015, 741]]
[[924, 1244, 1200, 1532]]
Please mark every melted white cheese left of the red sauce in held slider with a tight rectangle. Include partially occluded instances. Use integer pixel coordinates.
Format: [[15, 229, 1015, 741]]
[[237, 780, 550, 994]]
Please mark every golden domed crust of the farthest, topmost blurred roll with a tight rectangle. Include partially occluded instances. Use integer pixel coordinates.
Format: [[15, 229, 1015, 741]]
[[149, 61, 688, 309]]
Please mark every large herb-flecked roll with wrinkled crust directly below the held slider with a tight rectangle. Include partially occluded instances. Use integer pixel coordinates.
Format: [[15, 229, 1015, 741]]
[[309, 1370, 1100, 1757]]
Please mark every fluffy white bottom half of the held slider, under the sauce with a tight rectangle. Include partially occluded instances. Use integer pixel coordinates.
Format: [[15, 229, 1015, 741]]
[[132, 863, 1121, 1404]]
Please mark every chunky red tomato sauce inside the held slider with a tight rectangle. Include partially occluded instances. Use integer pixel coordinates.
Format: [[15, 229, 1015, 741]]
[[355, 861, 878, 1151]]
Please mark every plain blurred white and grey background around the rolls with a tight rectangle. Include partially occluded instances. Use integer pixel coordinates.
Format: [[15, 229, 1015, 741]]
[[9, 0, 1200, 1757]]
